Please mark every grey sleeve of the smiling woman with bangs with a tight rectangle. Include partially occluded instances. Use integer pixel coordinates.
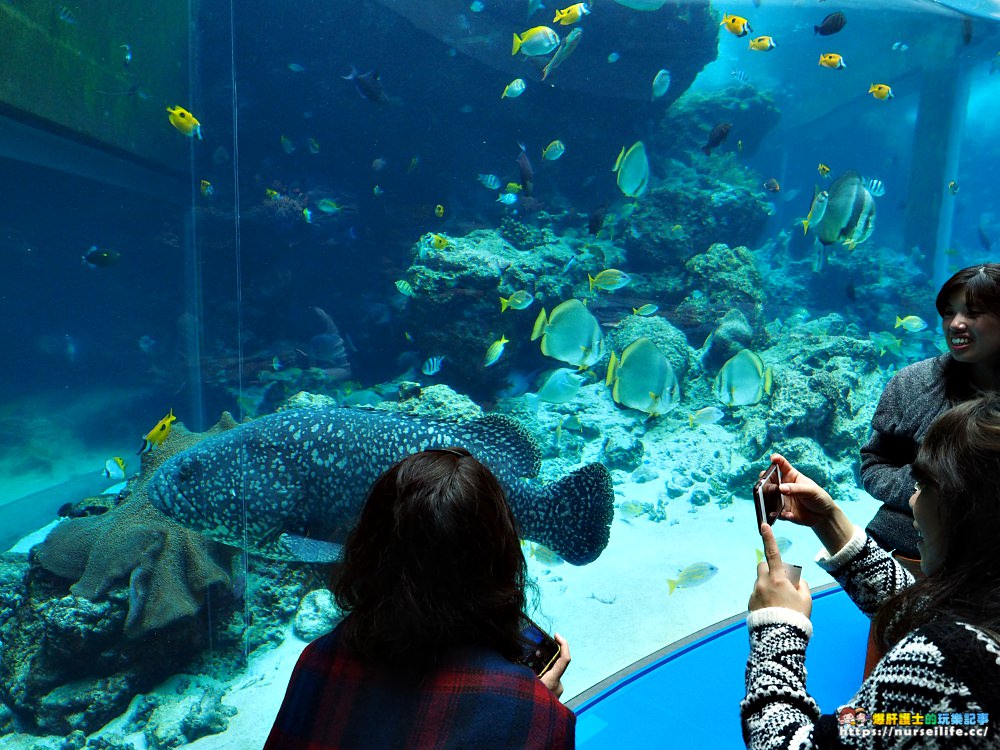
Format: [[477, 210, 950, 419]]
[[861, 358, 947, 513]]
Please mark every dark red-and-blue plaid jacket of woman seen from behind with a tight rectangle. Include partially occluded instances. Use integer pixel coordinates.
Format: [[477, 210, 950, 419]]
[[264, 630, 576, 750]]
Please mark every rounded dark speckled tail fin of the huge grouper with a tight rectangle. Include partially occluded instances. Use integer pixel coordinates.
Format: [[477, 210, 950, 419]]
[[511, 464, 615, 565]]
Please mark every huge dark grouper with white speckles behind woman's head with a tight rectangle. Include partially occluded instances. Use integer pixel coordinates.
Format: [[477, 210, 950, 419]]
[[149, 407, 614, 565]]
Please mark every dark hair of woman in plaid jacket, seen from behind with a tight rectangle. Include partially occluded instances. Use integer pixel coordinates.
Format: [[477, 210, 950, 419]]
[[332, 448, 527, 669]]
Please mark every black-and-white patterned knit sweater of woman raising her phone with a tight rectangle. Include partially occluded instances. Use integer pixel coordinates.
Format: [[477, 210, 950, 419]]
[[740, 529, 1000, 750]]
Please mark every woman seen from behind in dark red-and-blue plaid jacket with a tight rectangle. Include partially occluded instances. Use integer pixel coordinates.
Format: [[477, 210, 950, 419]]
[[265, 448, 576, 750]]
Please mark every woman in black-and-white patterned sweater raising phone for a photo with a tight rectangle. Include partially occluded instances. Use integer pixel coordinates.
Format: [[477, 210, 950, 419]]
[[740, 394, 1000, 749]]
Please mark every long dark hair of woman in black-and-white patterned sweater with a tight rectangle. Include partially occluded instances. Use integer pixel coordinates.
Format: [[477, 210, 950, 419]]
[[875, 393, 1000, 648]]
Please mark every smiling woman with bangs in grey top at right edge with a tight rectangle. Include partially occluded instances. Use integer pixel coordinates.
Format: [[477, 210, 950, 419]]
[[861, 263, 1000, 571]]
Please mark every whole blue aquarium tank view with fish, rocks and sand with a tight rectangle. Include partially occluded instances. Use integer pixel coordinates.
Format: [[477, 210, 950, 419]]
[[0, 0, 1000, 750]]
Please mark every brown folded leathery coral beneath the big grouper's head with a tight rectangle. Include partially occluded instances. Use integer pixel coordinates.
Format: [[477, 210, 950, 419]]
[[32, 412, 236, 638]]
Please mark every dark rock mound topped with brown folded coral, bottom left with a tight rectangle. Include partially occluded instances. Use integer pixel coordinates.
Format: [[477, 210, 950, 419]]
[[0, 415, 246, 734]]
